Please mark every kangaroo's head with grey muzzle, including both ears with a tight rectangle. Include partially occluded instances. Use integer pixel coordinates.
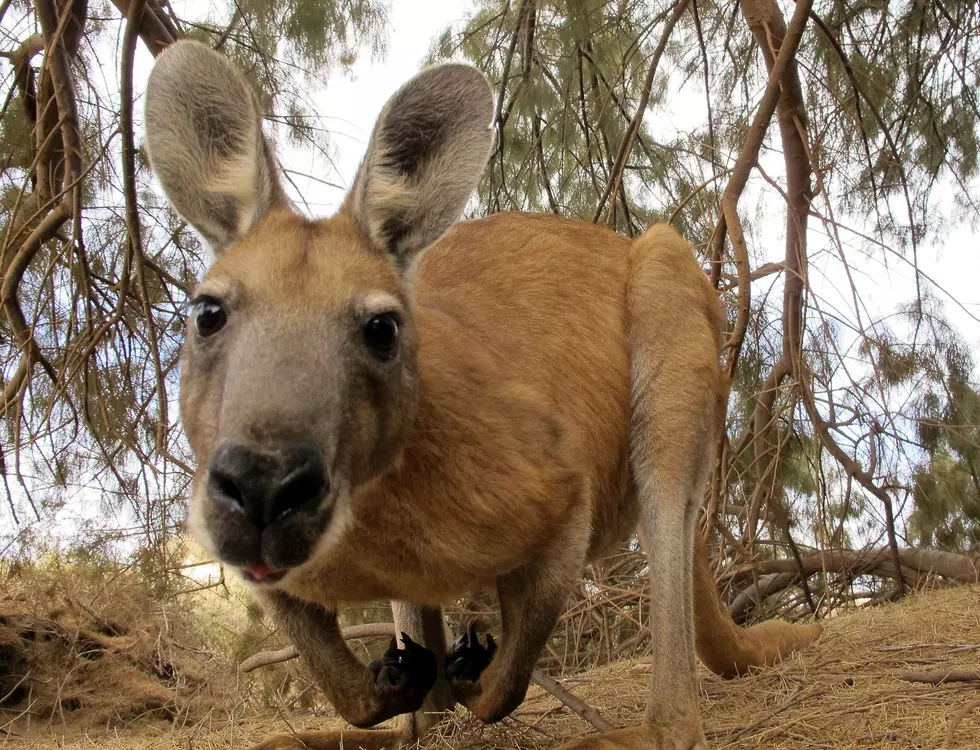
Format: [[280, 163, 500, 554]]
[[146, 41, 493, 584]]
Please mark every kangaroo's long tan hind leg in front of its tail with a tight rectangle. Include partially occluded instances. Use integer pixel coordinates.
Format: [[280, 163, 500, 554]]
[[565, 226, 723, 750]]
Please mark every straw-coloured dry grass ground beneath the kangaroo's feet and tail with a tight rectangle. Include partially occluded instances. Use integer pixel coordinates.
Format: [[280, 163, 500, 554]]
[[0, 586, 980, 750]]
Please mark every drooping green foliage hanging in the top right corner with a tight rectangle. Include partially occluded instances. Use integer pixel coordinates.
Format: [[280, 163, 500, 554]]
[[809, 0, 980, 246]]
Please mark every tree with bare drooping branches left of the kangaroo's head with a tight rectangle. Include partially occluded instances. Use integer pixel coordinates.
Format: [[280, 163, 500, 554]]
[[0, 0, 387, 569]]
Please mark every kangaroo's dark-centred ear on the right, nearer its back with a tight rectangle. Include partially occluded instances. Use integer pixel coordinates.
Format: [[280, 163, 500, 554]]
[[342, 63, 494, 270]]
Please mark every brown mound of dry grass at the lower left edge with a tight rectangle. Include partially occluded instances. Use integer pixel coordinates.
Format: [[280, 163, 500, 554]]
[[0, 565, 233, 746]]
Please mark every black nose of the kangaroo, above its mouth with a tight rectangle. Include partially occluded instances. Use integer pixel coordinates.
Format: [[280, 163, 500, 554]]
[[208, 440, 330, 528]]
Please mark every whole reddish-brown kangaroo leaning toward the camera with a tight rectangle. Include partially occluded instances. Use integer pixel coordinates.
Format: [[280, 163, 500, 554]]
[[145, 41, 820, 750]]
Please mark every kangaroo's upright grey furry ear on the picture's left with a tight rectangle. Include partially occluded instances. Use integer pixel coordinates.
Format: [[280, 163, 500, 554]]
[[146, 40, 290, 254]]
